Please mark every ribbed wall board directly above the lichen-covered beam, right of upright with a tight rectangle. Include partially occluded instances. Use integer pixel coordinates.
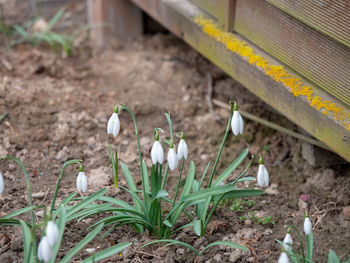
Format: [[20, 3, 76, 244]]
[[235, 0, 350, 108]]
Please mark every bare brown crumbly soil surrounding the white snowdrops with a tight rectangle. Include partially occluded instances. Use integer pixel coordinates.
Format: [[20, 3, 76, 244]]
[[0, 2, 350, 262]]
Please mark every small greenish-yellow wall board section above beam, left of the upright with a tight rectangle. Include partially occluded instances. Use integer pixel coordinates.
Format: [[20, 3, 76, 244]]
[[191, 0, 235, 31]]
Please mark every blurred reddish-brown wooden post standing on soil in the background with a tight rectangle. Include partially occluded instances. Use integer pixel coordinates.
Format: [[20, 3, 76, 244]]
[[88, 0, 143, 46]]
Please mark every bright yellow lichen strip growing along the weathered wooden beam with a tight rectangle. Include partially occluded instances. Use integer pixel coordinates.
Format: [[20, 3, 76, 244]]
[[195, 16, 350, 131]]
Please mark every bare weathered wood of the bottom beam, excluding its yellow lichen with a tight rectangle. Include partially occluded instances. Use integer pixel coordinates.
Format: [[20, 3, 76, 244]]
[[131, 0, 350, 161]]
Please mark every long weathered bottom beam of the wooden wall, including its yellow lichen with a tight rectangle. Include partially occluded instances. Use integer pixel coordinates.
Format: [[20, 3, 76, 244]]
[[132, 0, 350, 161]]
